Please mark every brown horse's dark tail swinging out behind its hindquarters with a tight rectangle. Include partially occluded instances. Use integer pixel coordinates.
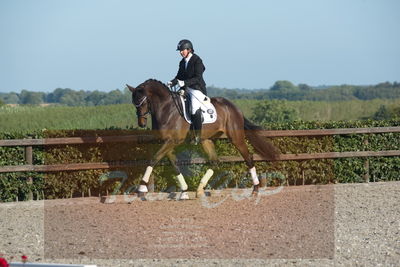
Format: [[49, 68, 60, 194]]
[[244, 118, 280, 160]]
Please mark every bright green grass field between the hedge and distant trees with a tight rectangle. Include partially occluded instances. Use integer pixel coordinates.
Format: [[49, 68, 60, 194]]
[[0, 99, 400, 132]]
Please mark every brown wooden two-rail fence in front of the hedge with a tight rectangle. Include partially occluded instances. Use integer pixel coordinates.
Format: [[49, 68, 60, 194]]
[[0, 127, 400, 178]]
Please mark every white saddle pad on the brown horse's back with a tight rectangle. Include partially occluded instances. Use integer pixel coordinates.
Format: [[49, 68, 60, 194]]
[[179, 96, 217, 124]]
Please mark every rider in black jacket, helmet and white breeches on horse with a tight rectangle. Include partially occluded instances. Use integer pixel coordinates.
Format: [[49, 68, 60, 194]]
[[167, 39, 207, 144]]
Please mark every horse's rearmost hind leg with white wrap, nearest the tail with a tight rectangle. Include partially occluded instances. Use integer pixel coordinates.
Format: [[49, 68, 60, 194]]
[[228, 130, 260, 194]]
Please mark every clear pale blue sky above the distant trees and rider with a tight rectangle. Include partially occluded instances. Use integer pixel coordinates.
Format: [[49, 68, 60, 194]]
[[0, 0, 400, 92]]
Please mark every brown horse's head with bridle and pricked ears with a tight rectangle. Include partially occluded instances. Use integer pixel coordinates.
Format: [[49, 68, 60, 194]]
[[126, 84, 151, 128]]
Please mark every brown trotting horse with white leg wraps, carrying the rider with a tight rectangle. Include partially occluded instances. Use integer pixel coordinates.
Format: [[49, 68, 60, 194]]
[[126, 79, 279, 200]]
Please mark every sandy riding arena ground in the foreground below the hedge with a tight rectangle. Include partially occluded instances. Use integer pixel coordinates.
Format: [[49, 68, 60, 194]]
[[0, 182, 400, 266]]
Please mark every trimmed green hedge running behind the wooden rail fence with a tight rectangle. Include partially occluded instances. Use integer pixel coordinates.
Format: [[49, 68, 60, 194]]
[[0, 121, 400, 201]]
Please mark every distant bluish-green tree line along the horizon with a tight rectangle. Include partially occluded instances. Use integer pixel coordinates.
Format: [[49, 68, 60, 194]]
[[0, 81, 400, 106]]
